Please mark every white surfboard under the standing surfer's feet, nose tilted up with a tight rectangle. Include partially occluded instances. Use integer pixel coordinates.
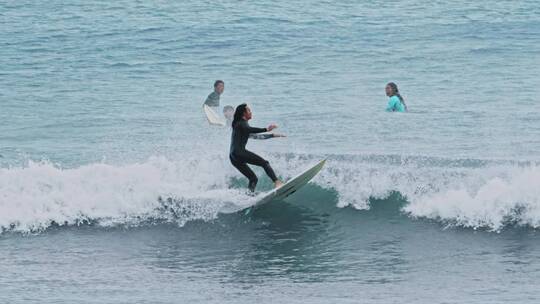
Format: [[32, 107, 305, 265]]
[[249, 159, 326, 209]]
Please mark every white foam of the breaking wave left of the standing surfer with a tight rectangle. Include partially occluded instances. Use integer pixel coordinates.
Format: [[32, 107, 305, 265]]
[[0, 157, 251, 231]]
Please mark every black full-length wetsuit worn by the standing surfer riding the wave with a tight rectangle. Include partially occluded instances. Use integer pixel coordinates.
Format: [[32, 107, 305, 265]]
[[229, 120, 277, 191]]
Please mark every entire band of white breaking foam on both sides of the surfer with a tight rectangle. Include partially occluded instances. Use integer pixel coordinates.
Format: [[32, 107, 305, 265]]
[[0, 154, 540, 232]]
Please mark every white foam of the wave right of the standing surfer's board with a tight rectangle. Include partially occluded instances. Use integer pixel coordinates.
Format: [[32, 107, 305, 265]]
[[312, 156, 540, 230]]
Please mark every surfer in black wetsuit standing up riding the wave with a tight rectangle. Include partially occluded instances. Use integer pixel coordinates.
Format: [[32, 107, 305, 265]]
[[229, 103, 283, 192]]
